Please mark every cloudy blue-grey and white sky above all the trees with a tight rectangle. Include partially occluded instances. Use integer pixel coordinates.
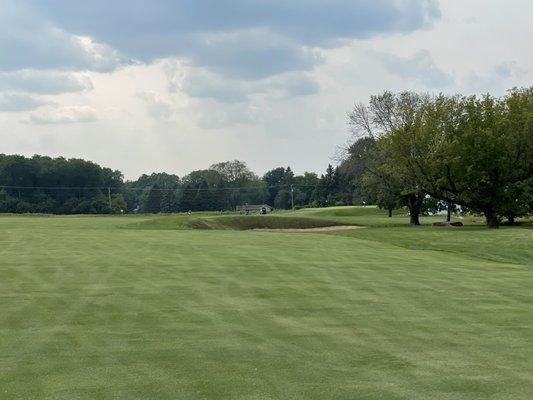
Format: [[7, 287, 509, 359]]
[[0, 0, 533, 179]]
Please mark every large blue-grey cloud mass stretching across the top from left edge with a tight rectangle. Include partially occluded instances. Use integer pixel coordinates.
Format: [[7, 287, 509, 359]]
[[0, 0, 440, 79]]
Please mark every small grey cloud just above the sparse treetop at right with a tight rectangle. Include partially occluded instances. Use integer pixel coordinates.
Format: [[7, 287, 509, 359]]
[[378, 50, 454, 88]]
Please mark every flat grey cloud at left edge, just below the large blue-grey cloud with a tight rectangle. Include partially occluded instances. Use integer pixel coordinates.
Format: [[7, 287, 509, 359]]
[[0, 70, 93, 94]]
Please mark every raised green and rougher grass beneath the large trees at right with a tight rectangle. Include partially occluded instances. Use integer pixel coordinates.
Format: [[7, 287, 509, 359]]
[[298, 207, 533, 265]]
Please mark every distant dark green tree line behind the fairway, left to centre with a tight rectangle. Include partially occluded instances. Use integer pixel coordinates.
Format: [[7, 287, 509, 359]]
[[0, 154, 355, 214]]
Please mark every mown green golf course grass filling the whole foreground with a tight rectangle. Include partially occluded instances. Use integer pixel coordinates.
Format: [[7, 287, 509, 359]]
[[0, 207, 533, 400]]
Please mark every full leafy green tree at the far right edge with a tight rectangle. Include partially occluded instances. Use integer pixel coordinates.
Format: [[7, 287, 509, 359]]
[[388, 90, 533, 228]]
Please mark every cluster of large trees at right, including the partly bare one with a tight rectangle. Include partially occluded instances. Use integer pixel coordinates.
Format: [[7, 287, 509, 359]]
[[341, 88, 533, 228]]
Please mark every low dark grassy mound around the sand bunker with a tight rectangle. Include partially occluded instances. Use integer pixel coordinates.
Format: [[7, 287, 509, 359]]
[[185, 215, 345, 231]]
